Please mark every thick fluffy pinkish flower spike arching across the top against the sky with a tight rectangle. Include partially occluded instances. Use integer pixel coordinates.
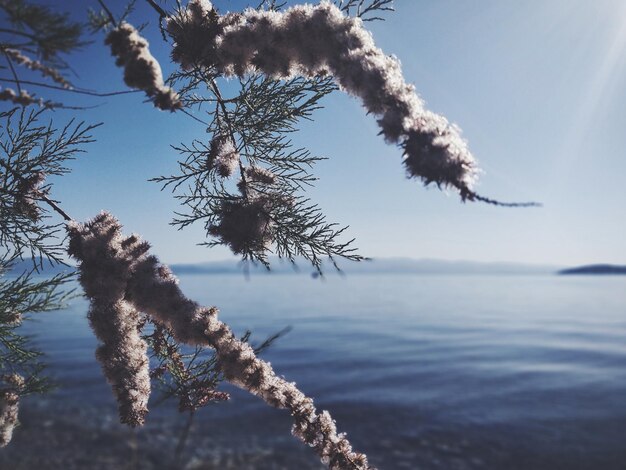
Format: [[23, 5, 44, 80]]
[[167, 0, 477, 199]]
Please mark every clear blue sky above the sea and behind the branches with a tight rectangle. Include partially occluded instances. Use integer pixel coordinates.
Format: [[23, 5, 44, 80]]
[[29, 0, 626, 265]]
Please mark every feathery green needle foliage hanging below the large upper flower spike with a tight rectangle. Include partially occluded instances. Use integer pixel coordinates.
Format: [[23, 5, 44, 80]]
[[154, 67, 363, 272]]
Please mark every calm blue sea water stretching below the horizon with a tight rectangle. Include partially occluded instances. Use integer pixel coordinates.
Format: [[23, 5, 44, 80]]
[[0, 275, 626, 470]]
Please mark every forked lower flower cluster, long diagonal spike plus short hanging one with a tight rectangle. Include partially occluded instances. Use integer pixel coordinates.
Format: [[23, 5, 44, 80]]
[[68, 212, 372, 470]]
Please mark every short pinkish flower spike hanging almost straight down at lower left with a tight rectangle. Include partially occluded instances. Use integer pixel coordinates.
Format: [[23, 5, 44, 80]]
[[68, 213, 150, 426]]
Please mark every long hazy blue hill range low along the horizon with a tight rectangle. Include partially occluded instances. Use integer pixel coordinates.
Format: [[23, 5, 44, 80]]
[[171, 258, 559, 275]]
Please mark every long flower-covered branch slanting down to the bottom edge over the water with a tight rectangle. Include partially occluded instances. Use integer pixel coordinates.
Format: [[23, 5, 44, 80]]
[[69, 213, 373, 470]]
